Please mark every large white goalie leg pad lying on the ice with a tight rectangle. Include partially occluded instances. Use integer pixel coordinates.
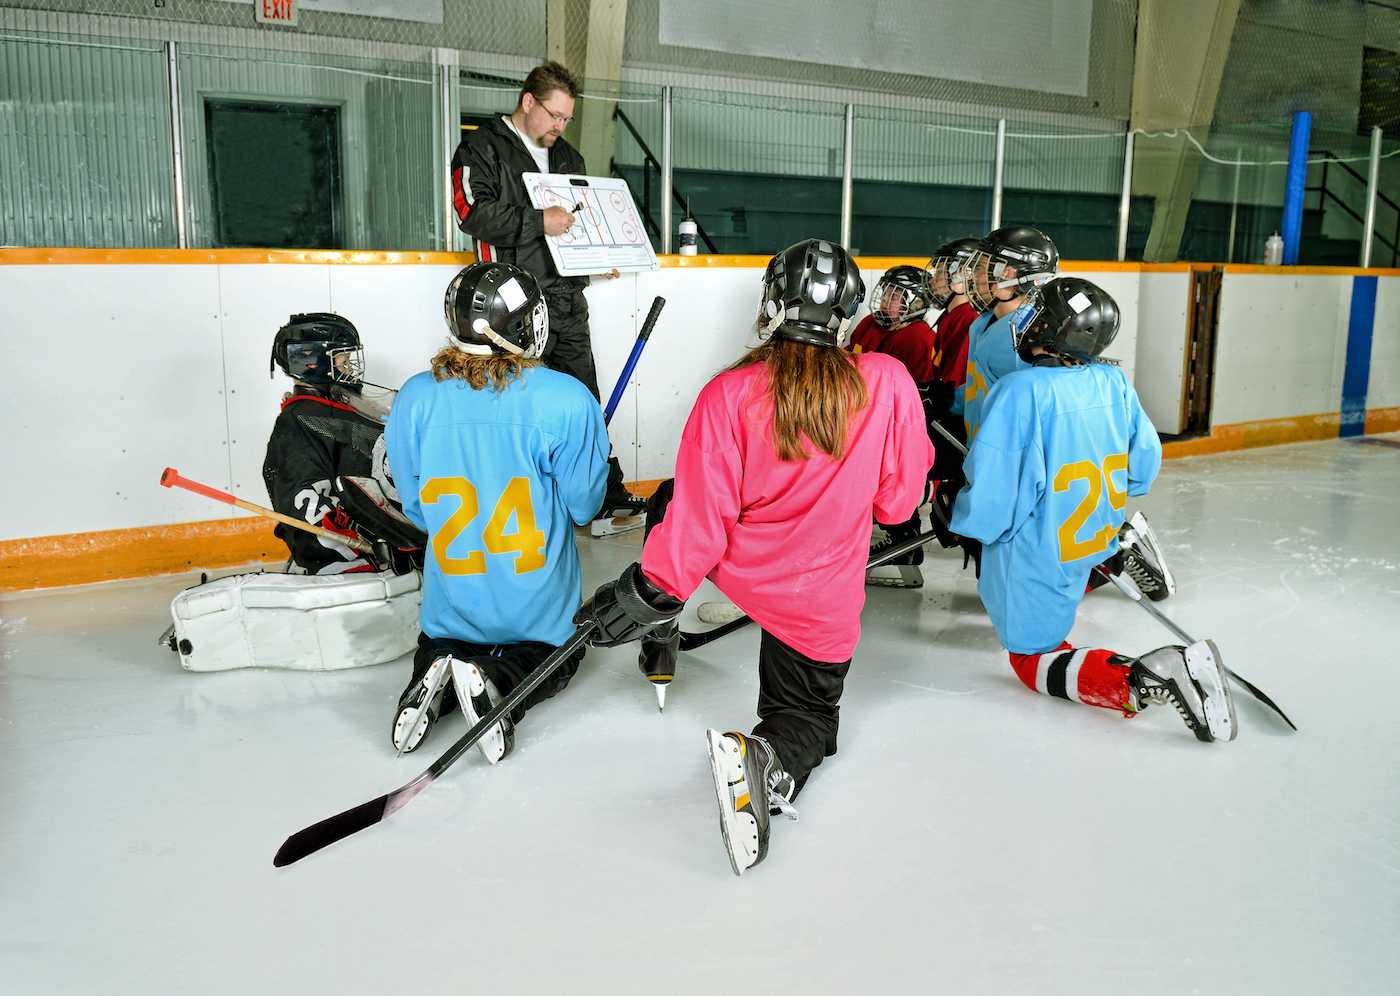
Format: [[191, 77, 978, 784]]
[[171, 570, 421, 671]]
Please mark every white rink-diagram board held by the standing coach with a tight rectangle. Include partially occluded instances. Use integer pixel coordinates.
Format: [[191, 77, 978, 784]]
[[521, 172, 657, 276]]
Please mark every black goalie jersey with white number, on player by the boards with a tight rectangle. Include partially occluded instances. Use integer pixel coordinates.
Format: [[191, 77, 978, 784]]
[[263, 394, 398, 574]]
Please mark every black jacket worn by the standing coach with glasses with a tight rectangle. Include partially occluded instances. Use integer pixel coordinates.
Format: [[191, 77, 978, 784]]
[[452, 115, 588, 299]]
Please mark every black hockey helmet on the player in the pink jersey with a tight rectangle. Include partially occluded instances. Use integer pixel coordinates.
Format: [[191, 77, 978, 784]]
[[757, 238, 865, 346]]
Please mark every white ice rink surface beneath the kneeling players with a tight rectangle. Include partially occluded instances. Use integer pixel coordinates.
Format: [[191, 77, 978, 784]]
[[0, 436, 1400, 996]]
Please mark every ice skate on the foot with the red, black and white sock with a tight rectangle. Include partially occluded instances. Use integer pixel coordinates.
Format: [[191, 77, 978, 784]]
[[1128, 640, 1239, 744]]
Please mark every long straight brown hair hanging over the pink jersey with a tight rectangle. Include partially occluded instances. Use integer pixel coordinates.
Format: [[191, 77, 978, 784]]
[[729, 339, 869, 461]]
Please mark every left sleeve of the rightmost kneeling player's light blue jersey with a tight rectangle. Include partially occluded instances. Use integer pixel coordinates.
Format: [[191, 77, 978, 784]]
[[951, 377, 1046, 544]]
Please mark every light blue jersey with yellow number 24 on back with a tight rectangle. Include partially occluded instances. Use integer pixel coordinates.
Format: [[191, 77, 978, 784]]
[[385, 367, 608, 646]]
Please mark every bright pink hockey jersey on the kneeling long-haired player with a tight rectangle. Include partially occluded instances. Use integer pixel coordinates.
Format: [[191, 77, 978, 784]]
[[641, 353, 934, 663]]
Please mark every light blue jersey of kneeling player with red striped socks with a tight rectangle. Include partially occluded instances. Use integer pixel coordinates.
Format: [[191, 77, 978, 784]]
[[952, 363, 1162, 654]]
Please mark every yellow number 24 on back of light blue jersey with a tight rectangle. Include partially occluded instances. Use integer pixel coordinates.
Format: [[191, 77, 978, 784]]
[[419, 478, 545, 576]]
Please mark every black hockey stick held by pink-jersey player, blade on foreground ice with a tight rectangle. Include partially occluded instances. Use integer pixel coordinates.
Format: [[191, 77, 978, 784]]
[[272, 623, 594, 869]]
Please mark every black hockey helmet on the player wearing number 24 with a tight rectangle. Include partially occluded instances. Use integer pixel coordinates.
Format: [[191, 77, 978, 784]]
[[442, 262, 549, 360]]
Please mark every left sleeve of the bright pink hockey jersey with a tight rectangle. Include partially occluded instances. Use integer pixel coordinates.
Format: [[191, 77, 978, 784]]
[[641, 388, 743, 601]]
